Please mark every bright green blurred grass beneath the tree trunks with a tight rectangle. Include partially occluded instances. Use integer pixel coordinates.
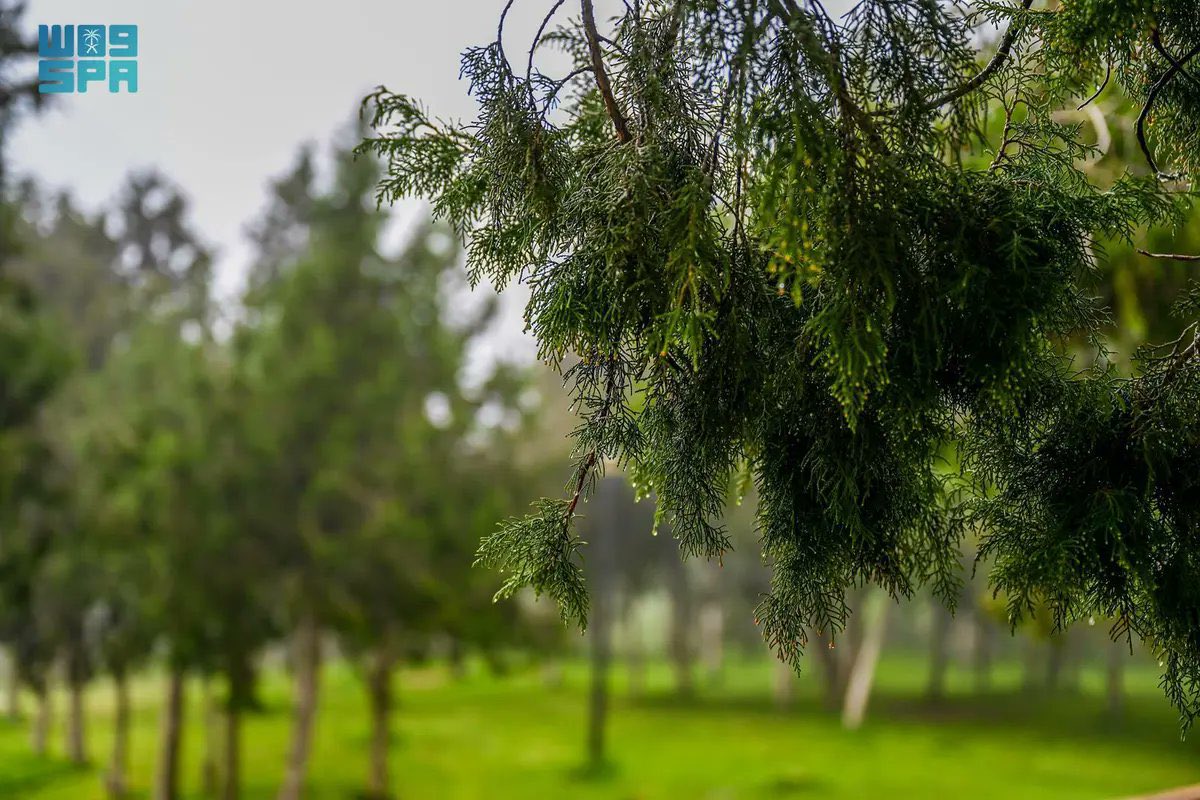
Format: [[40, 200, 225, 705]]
[[0, 657, 1200, 800]]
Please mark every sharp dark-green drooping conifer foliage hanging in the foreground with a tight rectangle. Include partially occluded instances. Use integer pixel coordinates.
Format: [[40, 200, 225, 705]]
[[361, 0, 1200, 723]]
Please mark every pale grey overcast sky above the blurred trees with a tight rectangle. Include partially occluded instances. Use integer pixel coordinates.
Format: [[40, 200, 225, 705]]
[[10, 0, 613, 359]]
